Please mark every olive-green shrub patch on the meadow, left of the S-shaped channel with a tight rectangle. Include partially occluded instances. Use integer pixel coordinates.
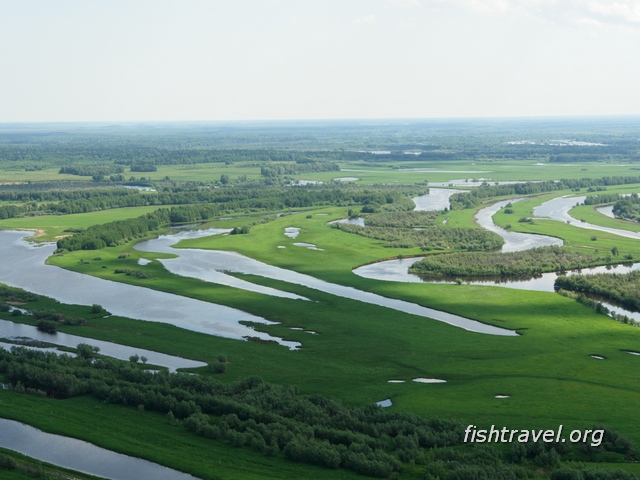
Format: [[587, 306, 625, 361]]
[[331, 223, 503, 251]]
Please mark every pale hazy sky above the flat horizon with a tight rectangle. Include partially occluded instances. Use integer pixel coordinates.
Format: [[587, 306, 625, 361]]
[[0, 0, 640, 122]]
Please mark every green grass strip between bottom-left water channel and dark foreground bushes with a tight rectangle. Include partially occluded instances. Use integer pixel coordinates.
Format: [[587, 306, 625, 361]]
[[0, 391, 362, 480]]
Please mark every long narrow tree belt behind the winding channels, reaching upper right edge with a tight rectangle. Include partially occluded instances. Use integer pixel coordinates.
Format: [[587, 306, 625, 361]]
[[450, 176, 640, 210]]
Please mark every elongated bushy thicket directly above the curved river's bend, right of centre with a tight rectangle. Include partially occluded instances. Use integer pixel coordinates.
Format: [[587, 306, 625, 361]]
[[409, 246, 611, 277]]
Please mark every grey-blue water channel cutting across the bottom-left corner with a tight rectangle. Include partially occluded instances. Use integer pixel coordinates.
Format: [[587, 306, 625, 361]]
[[0, 418, 196, 480]]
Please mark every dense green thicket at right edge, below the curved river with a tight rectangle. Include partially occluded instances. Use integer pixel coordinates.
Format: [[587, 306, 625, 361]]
[[554, 271, 640, 312]]
